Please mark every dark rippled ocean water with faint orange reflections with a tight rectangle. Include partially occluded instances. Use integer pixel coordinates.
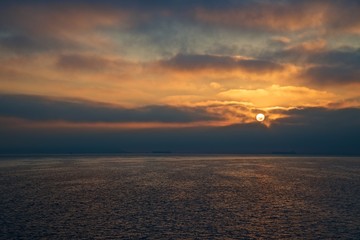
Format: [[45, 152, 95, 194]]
[[0, 155, 360, 239]]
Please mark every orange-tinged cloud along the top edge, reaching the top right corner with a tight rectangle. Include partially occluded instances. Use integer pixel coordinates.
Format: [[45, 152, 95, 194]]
[[195, 0, 360, 34]]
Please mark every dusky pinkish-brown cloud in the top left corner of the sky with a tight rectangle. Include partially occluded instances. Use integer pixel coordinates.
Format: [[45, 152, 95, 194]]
[[0, 1, 130, 54]]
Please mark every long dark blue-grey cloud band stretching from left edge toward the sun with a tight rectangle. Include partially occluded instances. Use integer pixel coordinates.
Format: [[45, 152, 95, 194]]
[[0, 95, 220, 123]]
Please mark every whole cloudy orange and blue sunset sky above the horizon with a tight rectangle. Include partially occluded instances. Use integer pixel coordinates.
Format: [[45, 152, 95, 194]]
[[0, 0, 360, 155]]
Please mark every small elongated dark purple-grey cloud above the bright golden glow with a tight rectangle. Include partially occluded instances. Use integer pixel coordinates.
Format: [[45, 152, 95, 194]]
[[161, 54, 282, 72]]
